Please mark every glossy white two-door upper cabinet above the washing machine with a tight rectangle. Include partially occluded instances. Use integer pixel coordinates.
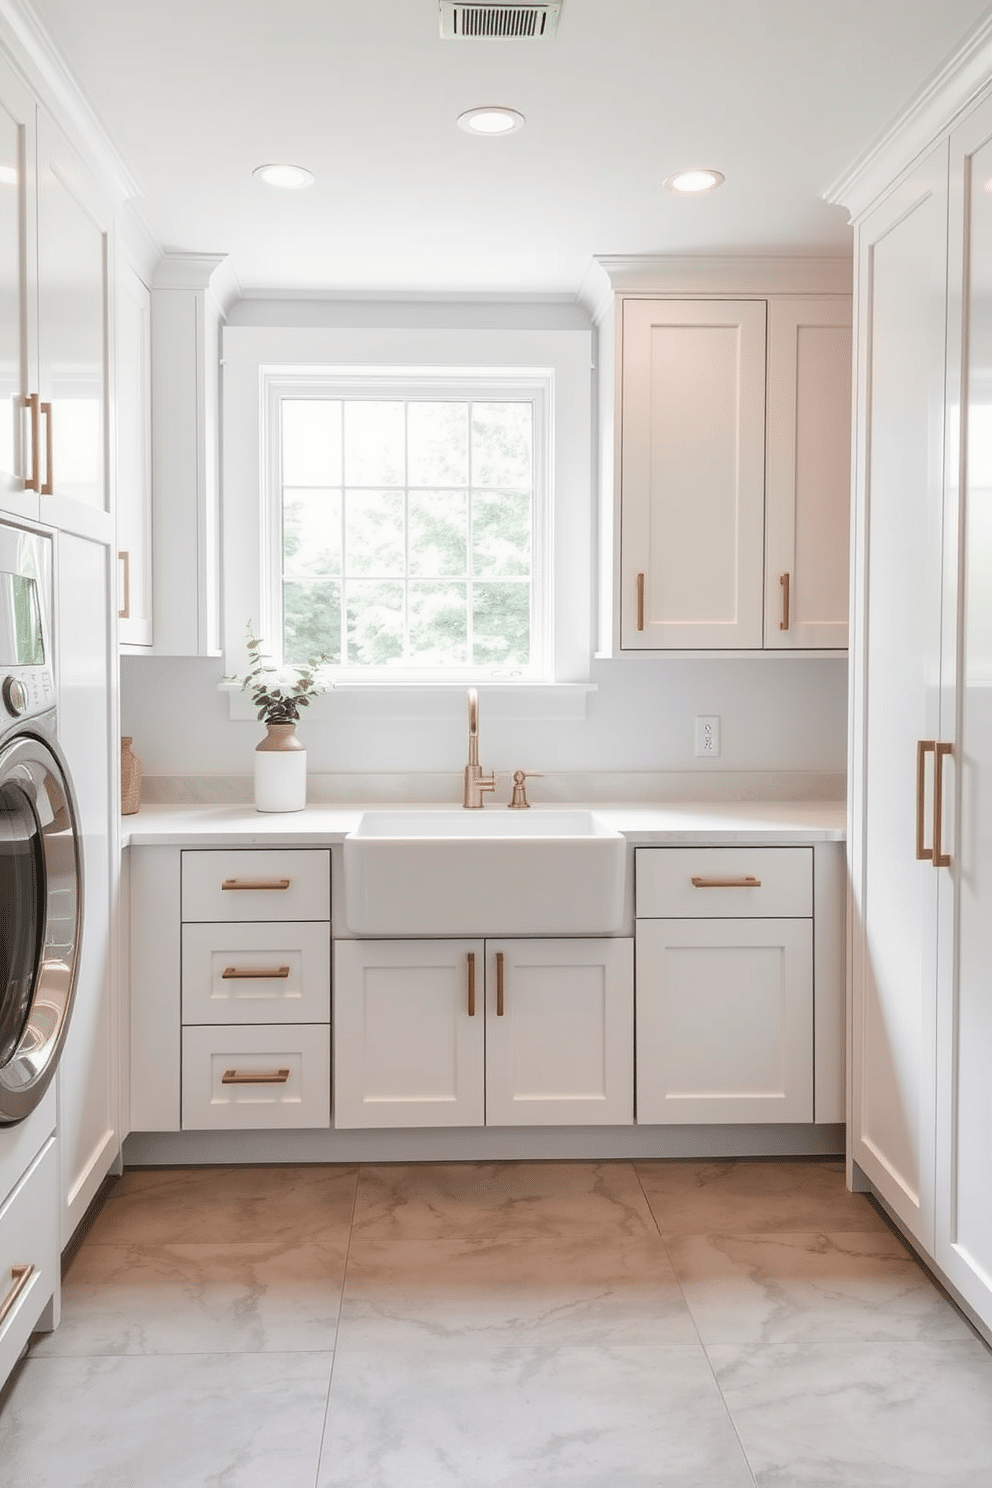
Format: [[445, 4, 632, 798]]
[[0, 68, 113, 540]]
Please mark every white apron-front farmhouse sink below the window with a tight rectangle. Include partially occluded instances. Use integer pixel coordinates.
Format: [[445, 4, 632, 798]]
[[345, 808, 626, 936]]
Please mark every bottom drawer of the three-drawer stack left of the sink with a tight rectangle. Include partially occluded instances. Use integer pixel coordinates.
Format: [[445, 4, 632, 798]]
[[183, 1024, 330, 1131]]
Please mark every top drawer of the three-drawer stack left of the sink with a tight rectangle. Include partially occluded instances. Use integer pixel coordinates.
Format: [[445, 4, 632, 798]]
[[183, 848, 330, 921]]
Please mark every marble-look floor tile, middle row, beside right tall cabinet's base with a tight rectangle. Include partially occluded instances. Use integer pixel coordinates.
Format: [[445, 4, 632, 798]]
[[666, 1231, 974, 1344]]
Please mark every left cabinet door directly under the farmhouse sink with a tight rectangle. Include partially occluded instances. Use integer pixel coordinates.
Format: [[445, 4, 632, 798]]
[[333, 940, 485, 1128]]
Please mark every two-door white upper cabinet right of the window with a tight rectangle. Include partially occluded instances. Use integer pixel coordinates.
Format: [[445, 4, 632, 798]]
[[601, 274, 852, 655]]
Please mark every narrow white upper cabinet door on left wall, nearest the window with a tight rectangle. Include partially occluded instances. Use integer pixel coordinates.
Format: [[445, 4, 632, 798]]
[[115, 263, 153, 646]]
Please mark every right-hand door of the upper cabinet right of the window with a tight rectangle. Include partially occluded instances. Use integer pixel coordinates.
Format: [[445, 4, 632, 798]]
[[764, 296, 851, 650]]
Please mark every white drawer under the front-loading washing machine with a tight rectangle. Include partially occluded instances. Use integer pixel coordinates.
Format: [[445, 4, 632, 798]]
[[0, 1140, 59, 1382]]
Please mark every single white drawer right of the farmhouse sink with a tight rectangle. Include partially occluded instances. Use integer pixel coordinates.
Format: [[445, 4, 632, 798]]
[[635, 847, 814, 920]]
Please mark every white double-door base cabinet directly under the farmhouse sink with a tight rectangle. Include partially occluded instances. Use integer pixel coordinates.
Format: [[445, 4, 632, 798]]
[[333, 939, 634, 1128]]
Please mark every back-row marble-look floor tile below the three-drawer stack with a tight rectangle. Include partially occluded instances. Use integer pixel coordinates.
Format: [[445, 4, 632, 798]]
[[86, 1164, 358, 1245]]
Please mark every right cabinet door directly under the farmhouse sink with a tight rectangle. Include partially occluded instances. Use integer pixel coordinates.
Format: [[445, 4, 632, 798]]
[[486, 939, 634, 1126]]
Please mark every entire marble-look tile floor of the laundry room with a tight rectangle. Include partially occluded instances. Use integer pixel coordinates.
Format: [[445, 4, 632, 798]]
[[0, 1161, 992, 1488]]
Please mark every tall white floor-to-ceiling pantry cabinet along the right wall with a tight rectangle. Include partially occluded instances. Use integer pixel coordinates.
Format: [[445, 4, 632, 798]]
[[842, 43, 992, 1330]]
